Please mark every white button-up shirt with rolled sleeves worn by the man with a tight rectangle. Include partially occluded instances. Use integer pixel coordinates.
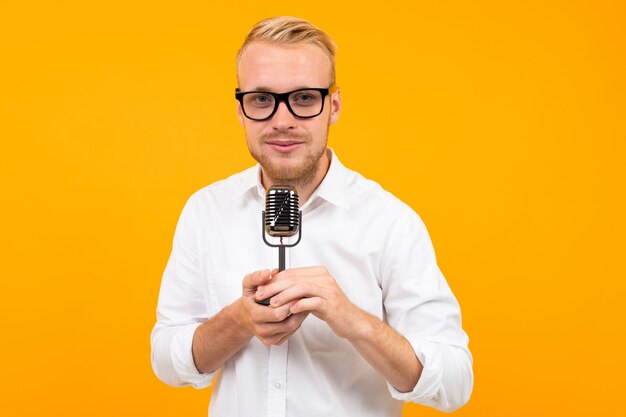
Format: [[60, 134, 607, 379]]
[[151, 151, 473, 417]]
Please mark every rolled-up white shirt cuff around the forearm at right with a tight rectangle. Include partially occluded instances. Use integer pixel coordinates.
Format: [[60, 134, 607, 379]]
[[387, 338, 443, 404]]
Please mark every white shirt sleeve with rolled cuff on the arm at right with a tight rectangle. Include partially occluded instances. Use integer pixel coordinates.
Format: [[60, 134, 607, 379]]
[[382, 210, 474, 412]]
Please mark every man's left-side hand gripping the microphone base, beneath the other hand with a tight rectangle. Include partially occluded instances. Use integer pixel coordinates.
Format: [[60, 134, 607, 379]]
[[237, 269, 309, 346]]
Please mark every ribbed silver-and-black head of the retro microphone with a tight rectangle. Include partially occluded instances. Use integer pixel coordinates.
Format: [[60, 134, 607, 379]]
[[265, 185, 300, 237]]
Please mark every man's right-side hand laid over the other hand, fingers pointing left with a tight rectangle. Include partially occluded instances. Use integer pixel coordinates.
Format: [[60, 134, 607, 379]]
[[257, 266, 366, 339]]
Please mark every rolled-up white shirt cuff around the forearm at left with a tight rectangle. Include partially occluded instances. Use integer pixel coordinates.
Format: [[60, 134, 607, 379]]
[[170, 323, 215, 388]]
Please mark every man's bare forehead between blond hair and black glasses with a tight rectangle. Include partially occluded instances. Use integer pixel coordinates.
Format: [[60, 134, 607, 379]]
[[237, 42, 331, 92]]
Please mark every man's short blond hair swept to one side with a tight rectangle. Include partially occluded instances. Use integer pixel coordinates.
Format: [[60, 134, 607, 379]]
[[237, 16, 337, 84]]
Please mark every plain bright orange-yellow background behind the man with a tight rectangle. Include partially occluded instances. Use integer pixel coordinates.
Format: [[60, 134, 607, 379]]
[[0, 0, 626, 417]]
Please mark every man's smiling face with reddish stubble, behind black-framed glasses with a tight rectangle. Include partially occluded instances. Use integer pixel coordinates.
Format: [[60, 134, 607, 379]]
[[237, 42, 341, 183]]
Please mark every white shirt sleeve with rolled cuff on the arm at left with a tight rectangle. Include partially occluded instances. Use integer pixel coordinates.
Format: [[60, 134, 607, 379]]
[[150, 196, 214, 388]]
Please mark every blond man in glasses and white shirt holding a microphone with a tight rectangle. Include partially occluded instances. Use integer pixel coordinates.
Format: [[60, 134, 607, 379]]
[[151, 17, 473, 417]]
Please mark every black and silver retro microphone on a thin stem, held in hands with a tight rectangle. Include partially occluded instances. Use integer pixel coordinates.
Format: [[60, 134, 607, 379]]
[[257, 185, 302, 306]]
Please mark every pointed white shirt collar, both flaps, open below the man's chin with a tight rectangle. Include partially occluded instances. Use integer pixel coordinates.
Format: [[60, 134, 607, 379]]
[[234, 148, 350, 209]]
